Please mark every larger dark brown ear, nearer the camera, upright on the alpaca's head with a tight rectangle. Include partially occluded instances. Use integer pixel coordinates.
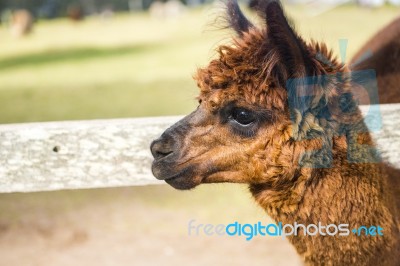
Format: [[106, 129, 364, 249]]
[[264, 0, 312, 78]]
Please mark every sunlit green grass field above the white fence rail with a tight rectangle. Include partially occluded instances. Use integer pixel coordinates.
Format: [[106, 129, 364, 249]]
[[0, 6, 397, 123]]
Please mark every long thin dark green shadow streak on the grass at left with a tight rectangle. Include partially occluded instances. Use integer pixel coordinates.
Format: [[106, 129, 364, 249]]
[[0, 45, 157, 70]]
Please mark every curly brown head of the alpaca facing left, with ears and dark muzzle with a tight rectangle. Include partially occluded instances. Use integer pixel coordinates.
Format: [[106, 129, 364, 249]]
[[151, 1, 366, 189]]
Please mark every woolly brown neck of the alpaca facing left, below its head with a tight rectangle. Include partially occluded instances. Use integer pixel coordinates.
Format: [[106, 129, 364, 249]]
[[250, 141, 400, 265]]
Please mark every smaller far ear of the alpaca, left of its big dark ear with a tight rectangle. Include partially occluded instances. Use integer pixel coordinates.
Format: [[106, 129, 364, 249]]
[[226, 0, 253, 36]]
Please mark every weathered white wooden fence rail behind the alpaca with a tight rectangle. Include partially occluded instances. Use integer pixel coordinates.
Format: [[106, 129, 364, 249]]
[[0, 104, 400, 192]]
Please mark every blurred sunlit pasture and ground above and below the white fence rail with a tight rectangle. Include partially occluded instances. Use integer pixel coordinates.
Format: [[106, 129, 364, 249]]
[[0, 0, 399, 266]]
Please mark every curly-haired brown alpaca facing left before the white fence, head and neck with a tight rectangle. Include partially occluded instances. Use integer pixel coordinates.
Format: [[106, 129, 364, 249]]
[[151, 1, 400, 266]]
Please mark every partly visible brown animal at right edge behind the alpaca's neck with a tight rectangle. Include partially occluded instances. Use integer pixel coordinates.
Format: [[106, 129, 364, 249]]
[[350, 15, 400, 103]]
